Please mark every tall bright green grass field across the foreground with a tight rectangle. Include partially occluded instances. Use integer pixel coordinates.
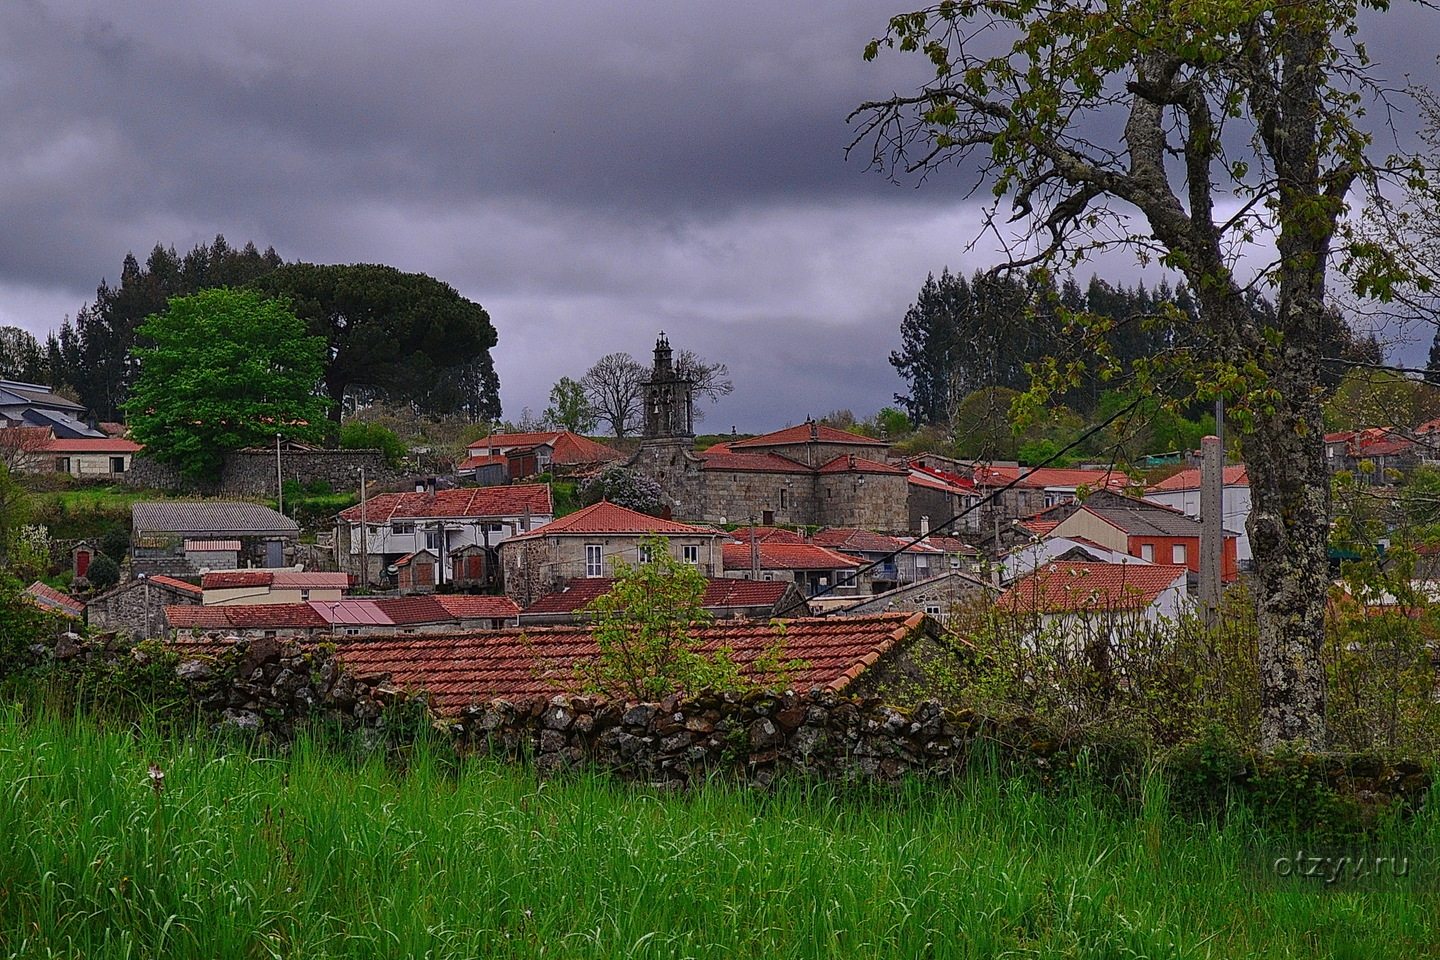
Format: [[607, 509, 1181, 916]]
[[0, 708, 1440, 959]]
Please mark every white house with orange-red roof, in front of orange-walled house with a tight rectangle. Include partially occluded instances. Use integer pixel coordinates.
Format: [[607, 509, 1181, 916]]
[[995, 561, 1189, 651]]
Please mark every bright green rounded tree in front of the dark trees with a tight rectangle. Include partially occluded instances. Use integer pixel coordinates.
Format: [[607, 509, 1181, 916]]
[[125, 288, 327, 479]]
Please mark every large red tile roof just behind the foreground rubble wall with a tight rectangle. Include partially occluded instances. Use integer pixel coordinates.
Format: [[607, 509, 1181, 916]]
[[173, 607, 932, 714]]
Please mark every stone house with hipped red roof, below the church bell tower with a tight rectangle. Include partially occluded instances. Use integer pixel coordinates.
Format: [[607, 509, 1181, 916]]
[[498, 500, 724, 606]]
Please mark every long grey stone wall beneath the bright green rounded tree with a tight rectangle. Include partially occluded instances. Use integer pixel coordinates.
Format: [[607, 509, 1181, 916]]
[[115, 450, 400, 497]]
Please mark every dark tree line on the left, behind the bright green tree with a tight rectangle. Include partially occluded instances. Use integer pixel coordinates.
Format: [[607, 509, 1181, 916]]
[[0, 236, 500, 420]]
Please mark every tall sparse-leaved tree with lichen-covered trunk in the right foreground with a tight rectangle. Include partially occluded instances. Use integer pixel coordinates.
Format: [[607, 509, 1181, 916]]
[[852, 0, 1411, 748]]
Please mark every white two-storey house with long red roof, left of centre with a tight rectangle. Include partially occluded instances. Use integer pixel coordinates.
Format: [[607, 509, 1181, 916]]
[[336, 484, 554, 592]]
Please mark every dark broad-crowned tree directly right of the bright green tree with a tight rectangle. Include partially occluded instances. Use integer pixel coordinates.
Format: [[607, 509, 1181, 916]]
[[249, 263, 500, 420]]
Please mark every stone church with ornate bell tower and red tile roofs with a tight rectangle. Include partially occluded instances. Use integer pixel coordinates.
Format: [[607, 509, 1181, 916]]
[[629, 334, 909, 533]]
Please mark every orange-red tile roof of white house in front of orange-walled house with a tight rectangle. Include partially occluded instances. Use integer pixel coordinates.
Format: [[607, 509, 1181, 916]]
[[995, 561, 1185, 613]]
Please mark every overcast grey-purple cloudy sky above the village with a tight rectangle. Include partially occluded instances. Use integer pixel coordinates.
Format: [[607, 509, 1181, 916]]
[[0, 0, 1440, 432]]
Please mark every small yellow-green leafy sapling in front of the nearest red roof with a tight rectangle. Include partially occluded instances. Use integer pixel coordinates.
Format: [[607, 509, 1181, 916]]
[[576, 537, 743, 701]]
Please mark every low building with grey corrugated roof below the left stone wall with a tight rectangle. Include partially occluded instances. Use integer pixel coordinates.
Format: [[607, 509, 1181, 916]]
[[130, 499, 300, 577]]
